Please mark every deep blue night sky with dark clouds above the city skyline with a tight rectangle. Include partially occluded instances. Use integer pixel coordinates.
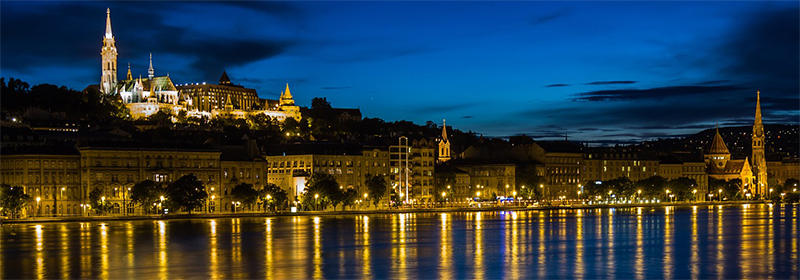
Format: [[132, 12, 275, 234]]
[[0, 1, 800, 141]]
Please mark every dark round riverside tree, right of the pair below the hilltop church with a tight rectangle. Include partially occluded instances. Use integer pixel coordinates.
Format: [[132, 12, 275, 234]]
[[167, 174, 208, 214]]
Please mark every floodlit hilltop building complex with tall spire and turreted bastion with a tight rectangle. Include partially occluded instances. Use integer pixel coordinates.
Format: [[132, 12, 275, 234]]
[[99, 9, 301, 121]]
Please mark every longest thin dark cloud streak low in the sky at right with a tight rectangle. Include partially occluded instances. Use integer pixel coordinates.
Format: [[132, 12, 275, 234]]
[[572, 85, 744, 102]]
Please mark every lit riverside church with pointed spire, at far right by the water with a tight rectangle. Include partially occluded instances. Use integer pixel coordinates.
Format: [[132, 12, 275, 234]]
[[705, 91, 769, 197]]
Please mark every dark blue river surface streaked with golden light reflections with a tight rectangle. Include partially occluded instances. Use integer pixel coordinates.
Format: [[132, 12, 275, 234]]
[[0, 204, 800, 279]]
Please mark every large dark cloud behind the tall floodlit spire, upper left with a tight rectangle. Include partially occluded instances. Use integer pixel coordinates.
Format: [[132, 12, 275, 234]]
[[1, 2, 300, 84]]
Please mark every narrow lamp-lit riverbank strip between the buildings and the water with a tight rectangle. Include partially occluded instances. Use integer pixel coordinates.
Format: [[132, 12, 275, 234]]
[[2, 200, 770, 224]]
